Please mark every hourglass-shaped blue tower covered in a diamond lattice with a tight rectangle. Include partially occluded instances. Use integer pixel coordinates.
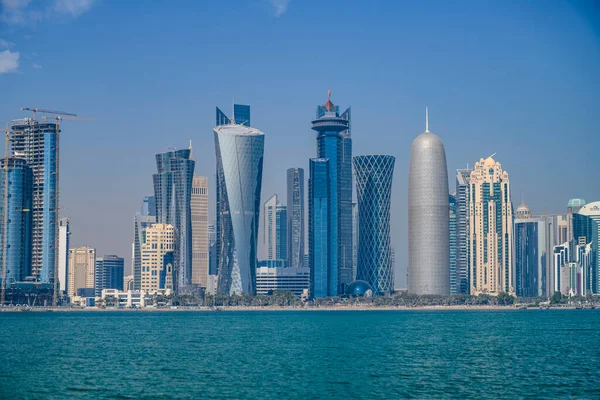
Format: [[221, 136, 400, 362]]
[[354, 155, 396, 294]]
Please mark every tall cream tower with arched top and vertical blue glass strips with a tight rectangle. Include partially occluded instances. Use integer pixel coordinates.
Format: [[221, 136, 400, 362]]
[[469, 156, 515, 295]]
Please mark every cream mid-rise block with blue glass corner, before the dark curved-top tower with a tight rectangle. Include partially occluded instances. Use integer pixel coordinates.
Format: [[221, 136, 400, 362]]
[[141, 224, 176, 293]]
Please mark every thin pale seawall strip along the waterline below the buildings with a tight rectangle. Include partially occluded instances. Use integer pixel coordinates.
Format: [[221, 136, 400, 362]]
[[0, 305, 592, 313]]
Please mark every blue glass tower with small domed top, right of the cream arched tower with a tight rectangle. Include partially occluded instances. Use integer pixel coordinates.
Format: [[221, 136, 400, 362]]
[[514, 204, 550, 297]]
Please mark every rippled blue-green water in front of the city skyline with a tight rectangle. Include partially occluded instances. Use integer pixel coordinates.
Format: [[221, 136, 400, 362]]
[[0, 310, 600, 399]]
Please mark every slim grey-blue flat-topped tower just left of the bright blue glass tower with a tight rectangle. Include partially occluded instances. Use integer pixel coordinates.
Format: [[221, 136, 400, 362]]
[[287, 168, 304, 268]]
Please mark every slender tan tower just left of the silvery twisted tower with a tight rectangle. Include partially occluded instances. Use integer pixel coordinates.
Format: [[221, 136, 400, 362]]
[[191, 176, 208, 287]]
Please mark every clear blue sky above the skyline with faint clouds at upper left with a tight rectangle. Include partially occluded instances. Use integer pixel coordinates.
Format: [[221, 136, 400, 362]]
[[0, 0, 600, 286]]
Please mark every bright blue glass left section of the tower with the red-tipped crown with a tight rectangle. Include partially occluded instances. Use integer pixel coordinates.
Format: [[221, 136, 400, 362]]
[[308, 158, 328, 298]]
